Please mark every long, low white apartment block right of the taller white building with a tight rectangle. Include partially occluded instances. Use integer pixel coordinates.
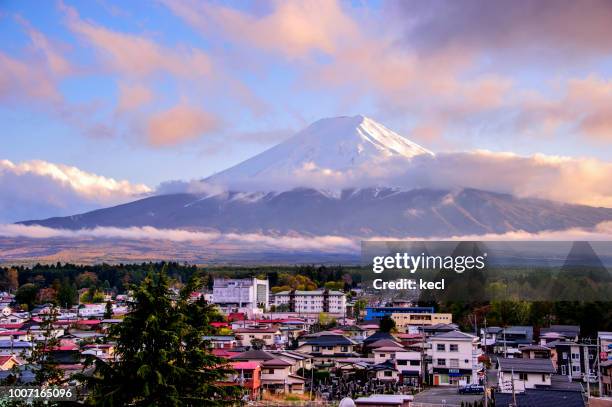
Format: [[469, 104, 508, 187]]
[[274, 290, 346, 315]]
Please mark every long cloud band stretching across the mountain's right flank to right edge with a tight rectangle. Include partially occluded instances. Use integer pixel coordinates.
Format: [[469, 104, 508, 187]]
[[207, 150, 612, 207]]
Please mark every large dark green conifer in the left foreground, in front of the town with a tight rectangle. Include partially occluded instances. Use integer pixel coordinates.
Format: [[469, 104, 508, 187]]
[[82, 269, 239, 406]]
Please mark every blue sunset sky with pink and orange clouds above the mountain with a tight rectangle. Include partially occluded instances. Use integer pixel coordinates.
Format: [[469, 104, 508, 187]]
[[0, 0, 612, 220]]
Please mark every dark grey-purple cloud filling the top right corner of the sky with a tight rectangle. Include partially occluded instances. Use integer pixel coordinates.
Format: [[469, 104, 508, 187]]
[[390, 0, 612, 62]]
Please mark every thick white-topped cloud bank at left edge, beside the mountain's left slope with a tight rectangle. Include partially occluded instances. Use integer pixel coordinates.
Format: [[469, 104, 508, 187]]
[[0, 160, 151, 221]]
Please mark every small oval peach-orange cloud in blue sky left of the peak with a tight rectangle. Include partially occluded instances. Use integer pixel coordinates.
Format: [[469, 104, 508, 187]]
[[146, 104, 219, 147]]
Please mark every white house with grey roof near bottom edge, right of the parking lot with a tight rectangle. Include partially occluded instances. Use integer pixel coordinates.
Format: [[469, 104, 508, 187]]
[[497, 358, 555, 393]]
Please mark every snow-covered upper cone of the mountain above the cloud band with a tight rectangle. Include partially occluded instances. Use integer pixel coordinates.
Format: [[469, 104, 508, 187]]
[[207, 115, 434, 187]]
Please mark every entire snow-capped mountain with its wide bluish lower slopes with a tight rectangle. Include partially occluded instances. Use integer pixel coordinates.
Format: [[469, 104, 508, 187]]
[[16, 116, 612, 238]]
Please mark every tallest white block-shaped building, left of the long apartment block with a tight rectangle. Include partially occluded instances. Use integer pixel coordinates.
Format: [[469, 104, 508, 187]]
[[212, 278, 270, 314]]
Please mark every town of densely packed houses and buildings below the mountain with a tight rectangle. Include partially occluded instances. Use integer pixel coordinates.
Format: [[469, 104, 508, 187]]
[[0, 264, 612, 407]]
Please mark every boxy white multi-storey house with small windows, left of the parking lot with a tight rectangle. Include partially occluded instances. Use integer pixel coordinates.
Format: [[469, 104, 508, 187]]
[[428, 331, 482, 386]]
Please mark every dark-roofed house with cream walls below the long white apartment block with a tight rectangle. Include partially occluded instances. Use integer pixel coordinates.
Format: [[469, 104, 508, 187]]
[[297, 331, 359, 368]]
